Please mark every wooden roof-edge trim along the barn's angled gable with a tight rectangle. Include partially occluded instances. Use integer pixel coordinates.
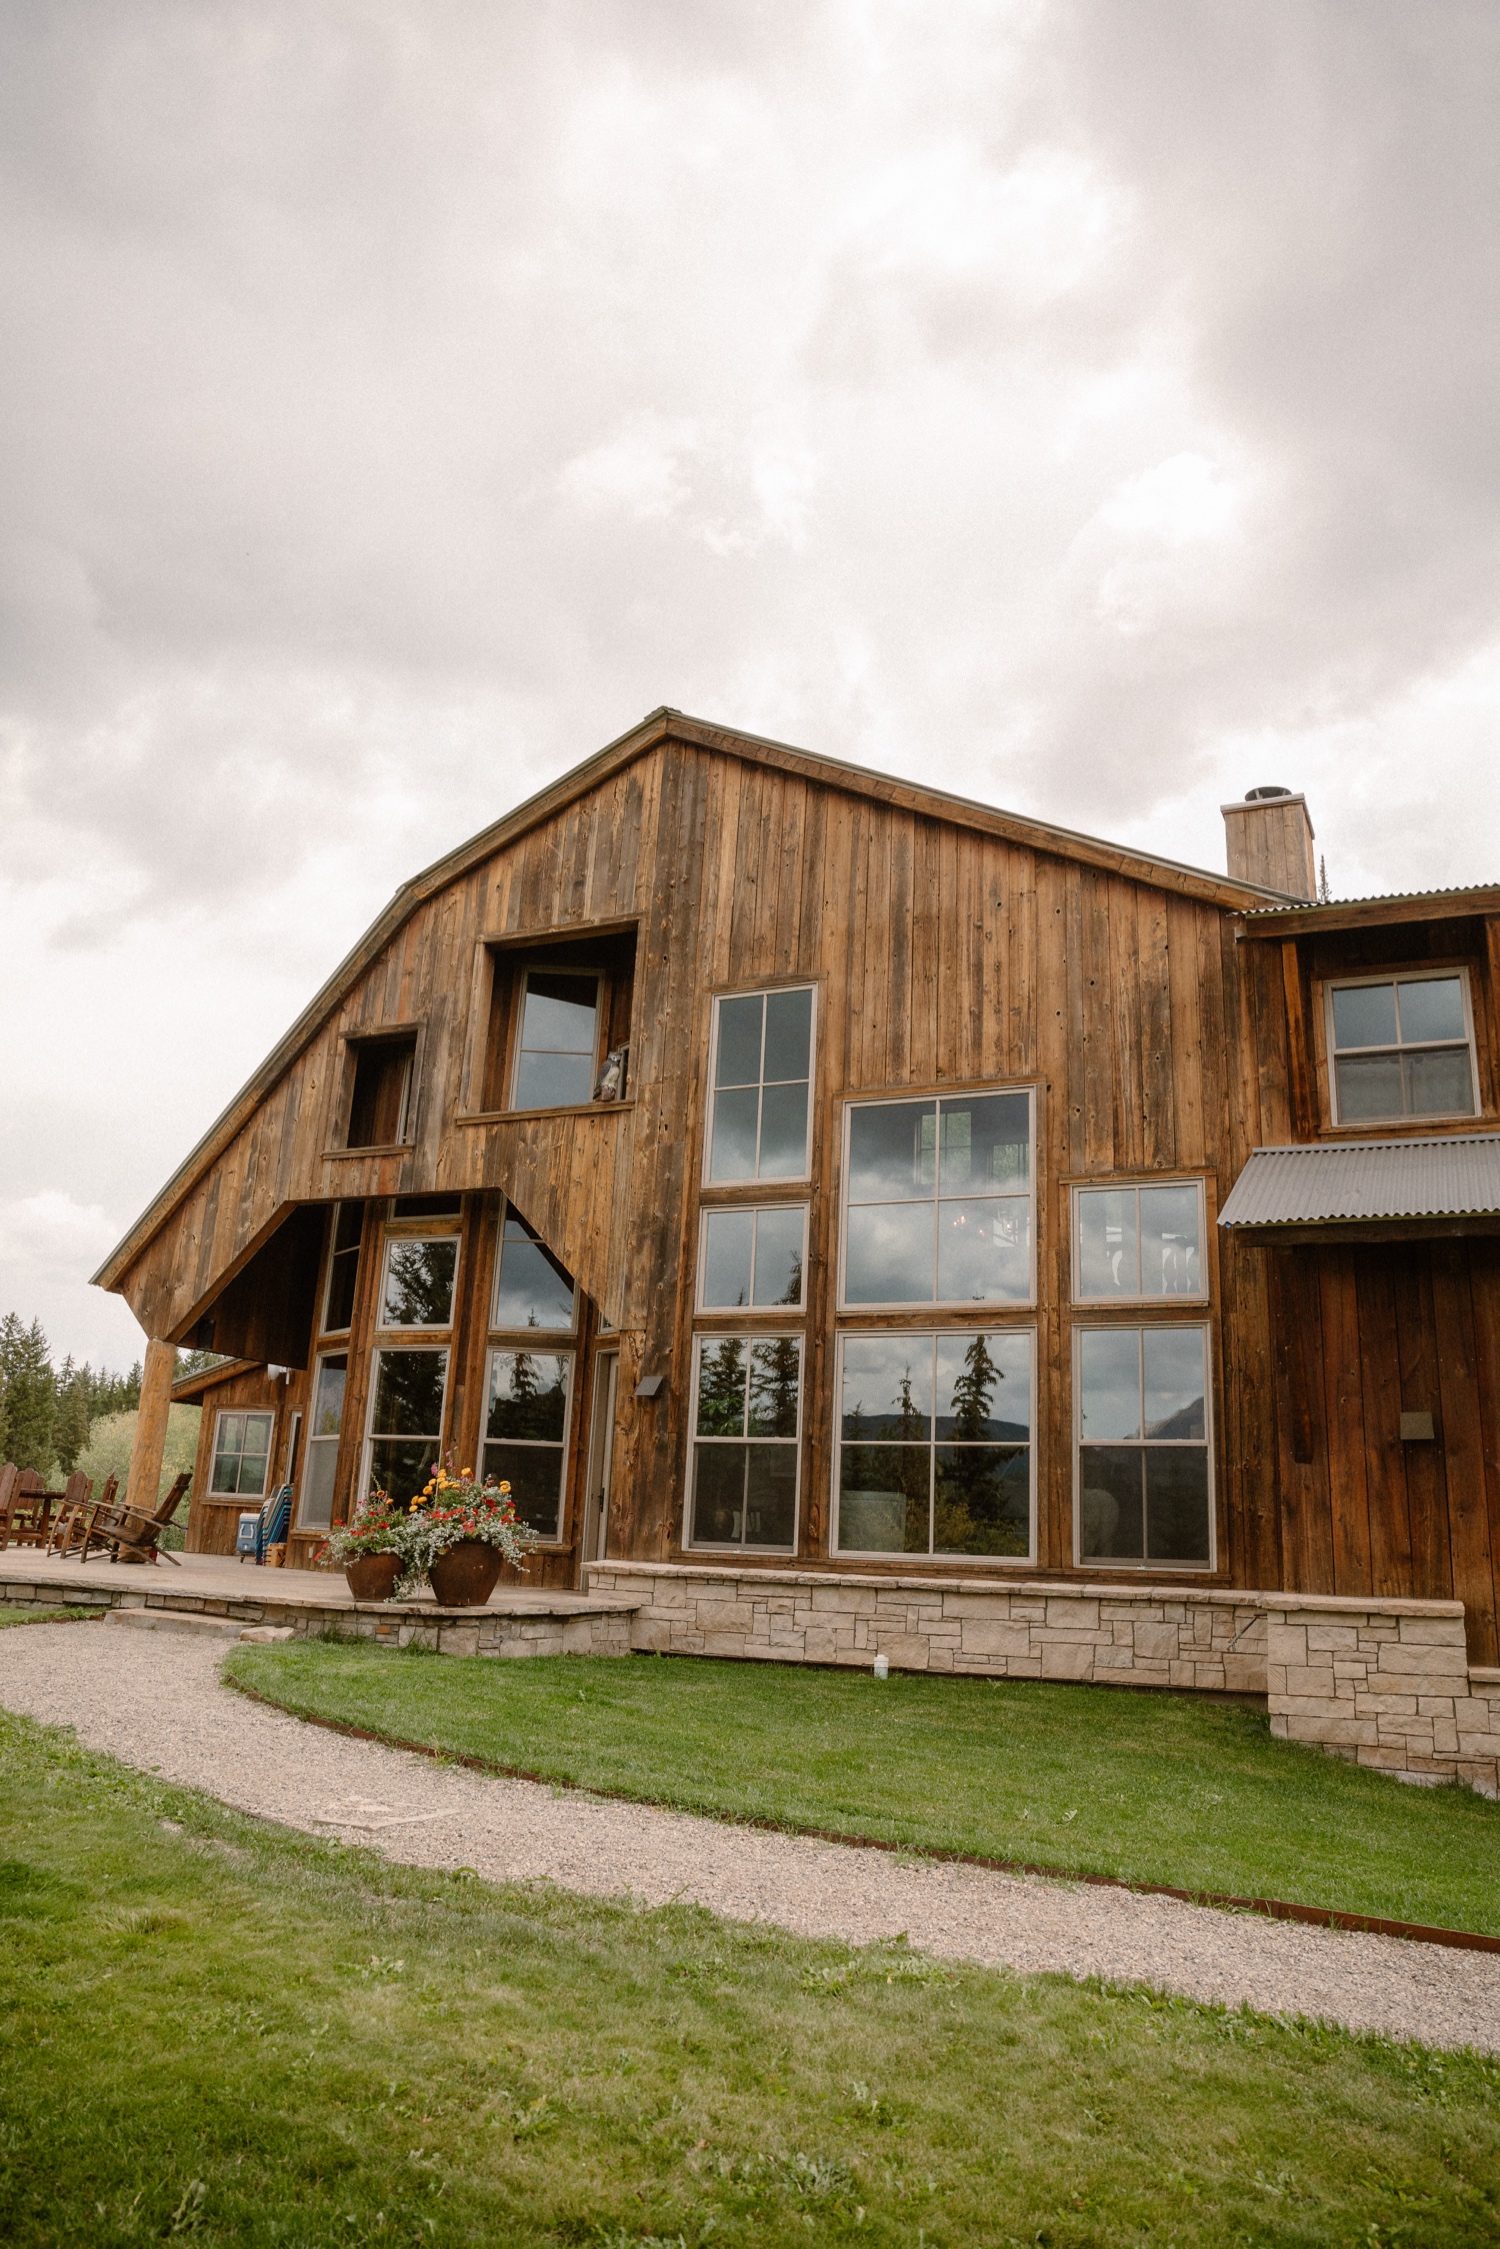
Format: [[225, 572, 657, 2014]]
[[92, 704, 1286, 1289]]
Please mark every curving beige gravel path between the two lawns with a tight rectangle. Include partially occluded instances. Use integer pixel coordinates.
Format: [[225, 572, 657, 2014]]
[[0, 1624, 1500, 2053]]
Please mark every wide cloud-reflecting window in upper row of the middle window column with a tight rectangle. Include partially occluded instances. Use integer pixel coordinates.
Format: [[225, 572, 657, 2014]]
[[843, 1093, 1032, 1304]]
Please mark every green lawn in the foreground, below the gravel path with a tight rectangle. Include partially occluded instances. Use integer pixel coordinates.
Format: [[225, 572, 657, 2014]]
[[0, 1700, 1500, 2249]]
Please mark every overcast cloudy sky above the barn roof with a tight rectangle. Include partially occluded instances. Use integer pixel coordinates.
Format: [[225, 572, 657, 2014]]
[[0, 0, 1500, 1363]]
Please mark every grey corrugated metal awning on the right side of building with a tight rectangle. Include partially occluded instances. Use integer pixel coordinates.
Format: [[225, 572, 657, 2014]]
[[1219, 1133, 1500, 1239]]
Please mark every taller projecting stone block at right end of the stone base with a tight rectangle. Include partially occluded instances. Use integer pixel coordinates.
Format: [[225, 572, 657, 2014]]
[[1266, 1595, 1500, 1797]]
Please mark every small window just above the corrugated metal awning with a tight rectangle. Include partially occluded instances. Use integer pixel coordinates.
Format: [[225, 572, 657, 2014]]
[[1329, 969, 1473, 1125]]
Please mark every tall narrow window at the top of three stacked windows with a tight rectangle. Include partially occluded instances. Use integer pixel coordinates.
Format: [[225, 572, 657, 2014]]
[[708, 985, 812, 1185]]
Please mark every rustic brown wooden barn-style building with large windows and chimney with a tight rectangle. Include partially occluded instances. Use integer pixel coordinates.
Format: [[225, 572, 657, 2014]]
[[97, 708, 1500, 1772]]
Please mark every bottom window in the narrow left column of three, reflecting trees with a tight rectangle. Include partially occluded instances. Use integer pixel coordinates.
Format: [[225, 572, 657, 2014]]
[[688, 1336, 803, 1554]]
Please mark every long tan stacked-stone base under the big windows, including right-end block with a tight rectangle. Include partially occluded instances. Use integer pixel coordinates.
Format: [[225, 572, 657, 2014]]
[[589, 1561, 1500, 1795]]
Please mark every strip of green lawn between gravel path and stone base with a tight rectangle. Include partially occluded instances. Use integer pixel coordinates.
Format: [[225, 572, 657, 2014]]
[[227, 1642, 1500, 1934]]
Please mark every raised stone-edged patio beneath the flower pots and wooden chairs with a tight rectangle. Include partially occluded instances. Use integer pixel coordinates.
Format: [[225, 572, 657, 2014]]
[[0, 1547, 641, 1655]]
